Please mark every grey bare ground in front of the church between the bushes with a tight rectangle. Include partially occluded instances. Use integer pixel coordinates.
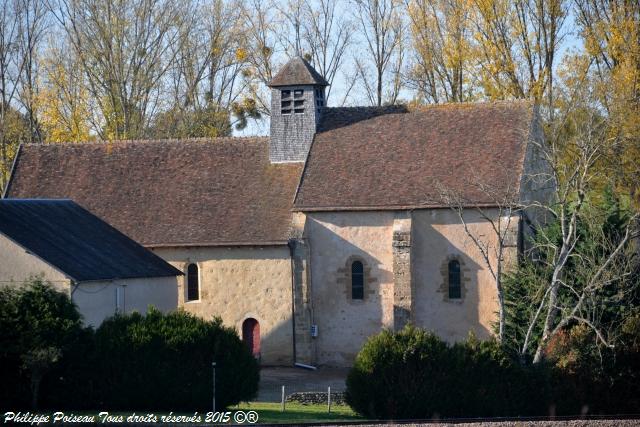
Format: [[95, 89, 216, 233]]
[[256, 367, 349, 402]]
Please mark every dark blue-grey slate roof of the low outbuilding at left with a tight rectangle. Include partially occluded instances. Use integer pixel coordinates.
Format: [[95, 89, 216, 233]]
[[0, 199, 182, 282]]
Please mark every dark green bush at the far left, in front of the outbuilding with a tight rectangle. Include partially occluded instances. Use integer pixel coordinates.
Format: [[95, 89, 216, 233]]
[[0, 277, 92, 408]]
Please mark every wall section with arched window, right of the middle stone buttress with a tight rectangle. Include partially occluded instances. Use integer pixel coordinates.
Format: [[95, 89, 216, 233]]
[[412, 210, 498, 342]]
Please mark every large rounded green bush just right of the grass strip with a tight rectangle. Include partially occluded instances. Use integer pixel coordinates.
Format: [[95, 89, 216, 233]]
[[346, 326, 547, 419]]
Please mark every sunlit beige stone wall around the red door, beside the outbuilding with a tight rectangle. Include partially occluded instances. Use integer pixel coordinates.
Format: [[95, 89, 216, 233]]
[[154, 245, 293, 365]]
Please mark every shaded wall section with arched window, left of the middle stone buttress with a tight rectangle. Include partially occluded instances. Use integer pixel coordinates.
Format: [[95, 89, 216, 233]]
[[305, 212, 393, 367]]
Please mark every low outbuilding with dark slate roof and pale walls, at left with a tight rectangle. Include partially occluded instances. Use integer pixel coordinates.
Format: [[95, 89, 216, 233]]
[[0, 199, 182, 326]]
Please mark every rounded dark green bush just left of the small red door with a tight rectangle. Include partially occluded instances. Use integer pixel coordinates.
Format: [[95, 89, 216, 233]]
[[95, 309, 259, 411]]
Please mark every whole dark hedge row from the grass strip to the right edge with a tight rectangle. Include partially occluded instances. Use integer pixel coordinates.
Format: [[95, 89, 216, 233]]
[[346, 326, 640, 419]]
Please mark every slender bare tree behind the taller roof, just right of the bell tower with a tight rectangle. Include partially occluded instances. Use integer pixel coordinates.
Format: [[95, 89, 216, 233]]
[[354, 0, 404, 106]]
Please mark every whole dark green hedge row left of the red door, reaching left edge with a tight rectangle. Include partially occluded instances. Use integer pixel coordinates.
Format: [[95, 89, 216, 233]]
[[0, 279, 259, 411]]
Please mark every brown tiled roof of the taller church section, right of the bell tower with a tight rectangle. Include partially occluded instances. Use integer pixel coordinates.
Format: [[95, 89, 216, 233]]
[[294, 101, 534, 211]]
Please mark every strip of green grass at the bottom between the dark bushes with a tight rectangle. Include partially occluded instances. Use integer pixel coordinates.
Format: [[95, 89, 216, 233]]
[[230, 402, 363, 424]]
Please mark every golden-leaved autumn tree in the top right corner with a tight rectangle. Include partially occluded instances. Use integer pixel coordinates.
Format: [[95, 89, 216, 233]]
[[576, 0, 640, 204]]
